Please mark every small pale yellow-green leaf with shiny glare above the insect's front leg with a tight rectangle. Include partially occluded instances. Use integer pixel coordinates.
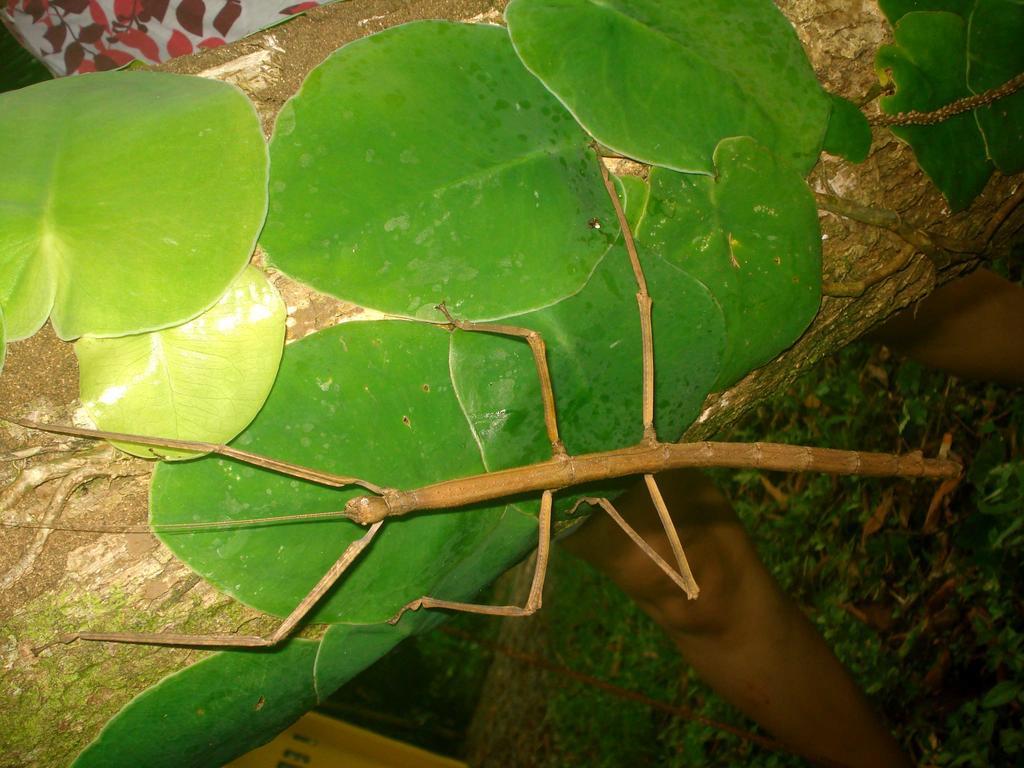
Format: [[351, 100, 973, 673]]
[[75, 267, 286, 459]]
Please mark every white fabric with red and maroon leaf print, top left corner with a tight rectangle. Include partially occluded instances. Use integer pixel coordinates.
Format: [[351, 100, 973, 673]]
[[0, 0, 324, 75]]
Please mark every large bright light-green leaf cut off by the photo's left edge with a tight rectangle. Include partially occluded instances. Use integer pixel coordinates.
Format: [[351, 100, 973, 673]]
[[0, 72, 266, 340]]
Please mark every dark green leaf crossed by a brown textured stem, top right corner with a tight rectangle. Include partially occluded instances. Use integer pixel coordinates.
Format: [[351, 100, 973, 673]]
[[876, 5, 1024, 211]]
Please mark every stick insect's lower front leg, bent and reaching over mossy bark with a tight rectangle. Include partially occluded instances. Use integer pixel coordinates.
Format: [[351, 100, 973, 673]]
[[36, 520, 384, 653]]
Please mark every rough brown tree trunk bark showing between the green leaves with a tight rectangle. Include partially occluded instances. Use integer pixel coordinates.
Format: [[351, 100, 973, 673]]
[[0, 0, 1021, 767]]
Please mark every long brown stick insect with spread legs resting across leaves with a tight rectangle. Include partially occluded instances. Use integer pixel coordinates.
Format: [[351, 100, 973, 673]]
[[4, 162, 961, 650]]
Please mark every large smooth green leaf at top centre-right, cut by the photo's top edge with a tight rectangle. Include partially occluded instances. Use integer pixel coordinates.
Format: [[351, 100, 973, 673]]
[[506, 0, 828, 173]]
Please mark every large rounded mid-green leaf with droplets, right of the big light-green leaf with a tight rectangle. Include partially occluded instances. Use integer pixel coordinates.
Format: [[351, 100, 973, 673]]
[[261, 22, 615, 319]]
